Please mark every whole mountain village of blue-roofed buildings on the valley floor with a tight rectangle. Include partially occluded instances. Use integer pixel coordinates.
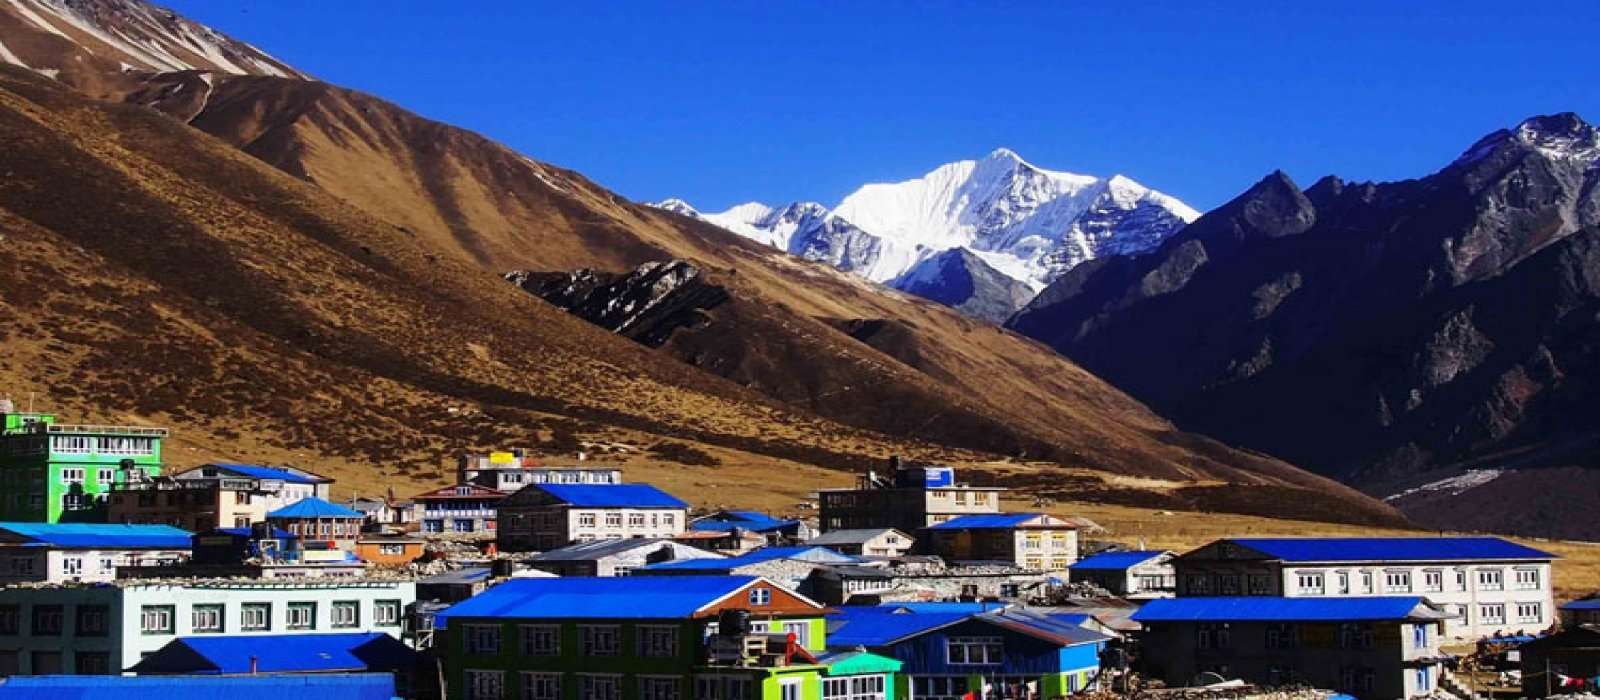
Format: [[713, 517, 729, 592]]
[[0, 404, 1600, 700]]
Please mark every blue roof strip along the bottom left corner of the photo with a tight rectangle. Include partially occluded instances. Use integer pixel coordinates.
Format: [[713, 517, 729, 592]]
[[0, 673, 397, 700]]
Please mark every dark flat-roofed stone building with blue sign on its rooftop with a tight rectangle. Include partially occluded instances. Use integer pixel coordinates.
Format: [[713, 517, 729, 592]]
[[818, 459, 1006, 532]]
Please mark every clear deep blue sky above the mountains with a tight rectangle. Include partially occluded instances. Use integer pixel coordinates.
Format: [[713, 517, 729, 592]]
[[157, 0, 1600, 209]]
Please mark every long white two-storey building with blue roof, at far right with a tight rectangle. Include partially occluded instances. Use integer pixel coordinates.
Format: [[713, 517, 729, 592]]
[[1173, 537, 1557, 639]]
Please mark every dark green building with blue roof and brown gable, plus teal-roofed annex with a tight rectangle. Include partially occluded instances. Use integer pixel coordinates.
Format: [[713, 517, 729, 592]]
[[435, 575, 901, 700]]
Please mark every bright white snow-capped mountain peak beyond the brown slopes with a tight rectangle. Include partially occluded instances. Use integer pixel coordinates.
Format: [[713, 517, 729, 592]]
[[656, 149, 1200, 297]]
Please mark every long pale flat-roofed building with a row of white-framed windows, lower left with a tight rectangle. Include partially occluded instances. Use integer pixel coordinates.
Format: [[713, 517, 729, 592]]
[[0, 580, 416, 676]]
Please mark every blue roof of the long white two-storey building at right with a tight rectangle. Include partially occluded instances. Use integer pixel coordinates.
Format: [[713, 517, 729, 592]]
[[1227, 537, 1557, 561]]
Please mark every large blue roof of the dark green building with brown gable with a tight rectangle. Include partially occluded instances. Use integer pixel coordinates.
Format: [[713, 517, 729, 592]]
[[434, 575, 757, 626]]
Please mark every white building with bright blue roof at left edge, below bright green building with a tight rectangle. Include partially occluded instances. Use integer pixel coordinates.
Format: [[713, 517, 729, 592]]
[[0, 523, 190, 585]]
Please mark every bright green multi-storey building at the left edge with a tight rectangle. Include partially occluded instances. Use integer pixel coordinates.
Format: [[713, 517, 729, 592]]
[[0, 401, 166, 523]]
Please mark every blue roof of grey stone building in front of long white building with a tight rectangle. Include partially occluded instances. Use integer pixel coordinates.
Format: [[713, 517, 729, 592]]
[[1133, 596, 1422, 622]]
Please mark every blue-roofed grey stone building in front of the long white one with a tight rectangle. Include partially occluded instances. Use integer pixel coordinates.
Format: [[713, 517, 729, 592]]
[[1133, 596, 1450, 698]]
